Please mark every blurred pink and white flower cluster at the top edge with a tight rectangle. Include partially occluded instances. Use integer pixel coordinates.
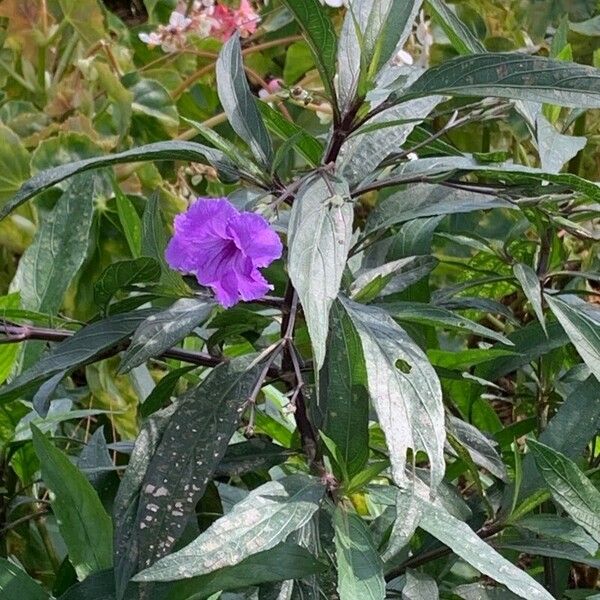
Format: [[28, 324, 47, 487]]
[[139, 0, 260, 52]]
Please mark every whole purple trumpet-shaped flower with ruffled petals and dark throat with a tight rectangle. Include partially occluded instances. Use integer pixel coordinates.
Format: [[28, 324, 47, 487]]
[[165, 198, 282, 307]]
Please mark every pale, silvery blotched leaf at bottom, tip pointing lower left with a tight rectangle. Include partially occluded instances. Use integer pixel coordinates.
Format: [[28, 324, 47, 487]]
[[135, 474, 325, 581]]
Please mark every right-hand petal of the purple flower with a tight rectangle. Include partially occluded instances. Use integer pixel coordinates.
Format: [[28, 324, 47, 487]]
[[227, 212, 283, 267]]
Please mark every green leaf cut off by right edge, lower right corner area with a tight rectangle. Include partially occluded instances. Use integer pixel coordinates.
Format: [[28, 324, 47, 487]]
[[527, 440, 600, 542]]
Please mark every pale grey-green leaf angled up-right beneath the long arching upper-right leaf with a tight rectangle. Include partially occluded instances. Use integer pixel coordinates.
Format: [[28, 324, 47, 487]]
[[339, 96, 442, 183]]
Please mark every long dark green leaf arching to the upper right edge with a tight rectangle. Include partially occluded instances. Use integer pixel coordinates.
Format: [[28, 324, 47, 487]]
[[404, 52, 600, 108]]
